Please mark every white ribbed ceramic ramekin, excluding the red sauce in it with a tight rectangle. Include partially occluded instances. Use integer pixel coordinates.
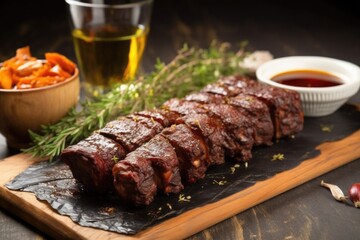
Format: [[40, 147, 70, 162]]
[[256, 56, 360, 117]]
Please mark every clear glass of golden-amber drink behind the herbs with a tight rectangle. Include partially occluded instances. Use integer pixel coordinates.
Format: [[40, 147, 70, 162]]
[[66, 0, 153, 97]]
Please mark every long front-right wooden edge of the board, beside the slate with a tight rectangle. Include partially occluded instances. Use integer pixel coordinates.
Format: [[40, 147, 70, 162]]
[[139, 130, 360, 239]]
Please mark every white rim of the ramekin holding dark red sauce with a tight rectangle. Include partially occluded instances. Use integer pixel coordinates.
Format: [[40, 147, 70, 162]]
[[256, 56, 360, 93]]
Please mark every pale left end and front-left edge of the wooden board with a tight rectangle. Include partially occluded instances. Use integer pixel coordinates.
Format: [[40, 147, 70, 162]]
[[0, 153, 131, 239]]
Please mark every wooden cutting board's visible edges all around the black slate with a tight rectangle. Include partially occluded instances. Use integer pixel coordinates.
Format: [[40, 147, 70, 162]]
[[0, 130, 360, 239]]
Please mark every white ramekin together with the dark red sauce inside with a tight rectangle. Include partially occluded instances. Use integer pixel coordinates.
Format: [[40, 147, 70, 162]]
[[256, 56, 360, 117]]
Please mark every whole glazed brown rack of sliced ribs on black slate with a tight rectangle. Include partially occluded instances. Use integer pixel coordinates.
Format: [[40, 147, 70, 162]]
[[60, 76, 304, 205]]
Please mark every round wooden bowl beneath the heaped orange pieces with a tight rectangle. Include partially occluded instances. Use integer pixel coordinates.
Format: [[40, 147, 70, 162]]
[[0, 66, 80, 149]]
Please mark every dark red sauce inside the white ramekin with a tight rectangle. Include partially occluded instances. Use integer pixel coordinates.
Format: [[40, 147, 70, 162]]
[[271, 70, 343, 87]]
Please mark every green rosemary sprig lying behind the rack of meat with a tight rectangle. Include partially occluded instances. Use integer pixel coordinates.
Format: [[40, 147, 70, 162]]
[[22, 43, 246, 160]]
